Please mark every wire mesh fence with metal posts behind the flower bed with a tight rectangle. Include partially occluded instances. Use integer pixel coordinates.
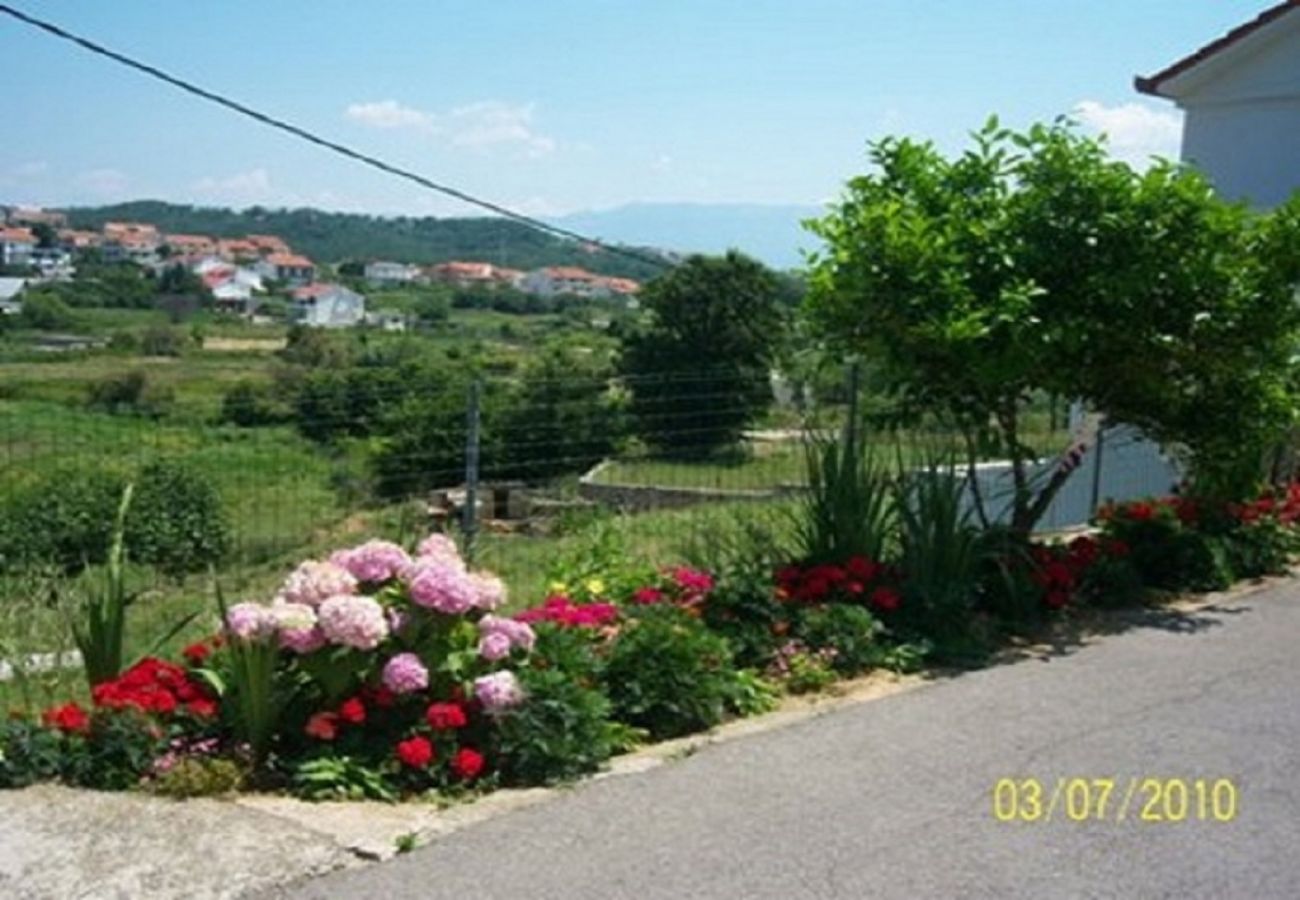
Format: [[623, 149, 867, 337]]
[[0, 358, 1092, 616]]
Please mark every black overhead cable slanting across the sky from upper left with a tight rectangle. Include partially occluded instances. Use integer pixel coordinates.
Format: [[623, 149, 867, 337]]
[[0, 3, 672, 269]]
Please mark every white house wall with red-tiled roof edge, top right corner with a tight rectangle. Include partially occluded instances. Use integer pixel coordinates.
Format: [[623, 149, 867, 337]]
[[1136, 0, 1300, 207]]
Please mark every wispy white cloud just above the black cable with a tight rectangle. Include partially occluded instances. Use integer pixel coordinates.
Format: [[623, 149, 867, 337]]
[[345, 100, 556, 157]]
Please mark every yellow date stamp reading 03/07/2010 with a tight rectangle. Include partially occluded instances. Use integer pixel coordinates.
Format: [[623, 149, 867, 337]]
[[992, 776, 1240, 825]]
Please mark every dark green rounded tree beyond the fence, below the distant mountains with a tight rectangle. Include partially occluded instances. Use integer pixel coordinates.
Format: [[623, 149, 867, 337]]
[[620, 251, 785, 458]]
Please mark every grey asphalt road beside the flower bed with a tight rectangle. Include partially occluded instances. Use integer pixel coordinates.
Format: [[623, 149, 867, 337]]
[[274, 585, 1300, 900]]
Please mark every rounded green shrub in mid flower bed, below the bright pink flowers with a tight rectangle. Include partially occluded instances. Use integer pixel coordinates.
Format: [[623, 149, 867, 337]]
[[605, 605, 736, 740]]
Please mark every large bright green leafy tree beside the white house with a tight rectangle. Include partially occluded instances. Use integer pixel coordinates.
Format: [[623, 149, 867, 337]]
[[805, 120, 1297, 531]]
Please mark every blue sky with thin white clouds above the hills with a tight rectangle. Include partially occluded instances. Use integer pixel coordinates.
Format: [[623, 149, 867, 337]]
[[0, 0, 1268, 215]]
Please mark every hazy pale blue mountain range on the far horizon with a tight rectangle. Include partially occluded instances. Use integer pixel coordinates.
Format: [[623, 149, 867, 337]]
[[553, 203, 823, 269]]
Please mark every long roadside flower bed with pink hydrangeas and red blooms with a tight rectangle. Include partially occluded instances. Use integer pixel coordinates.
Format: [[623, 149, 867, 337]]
[[0, 486, 1300, 800]]
